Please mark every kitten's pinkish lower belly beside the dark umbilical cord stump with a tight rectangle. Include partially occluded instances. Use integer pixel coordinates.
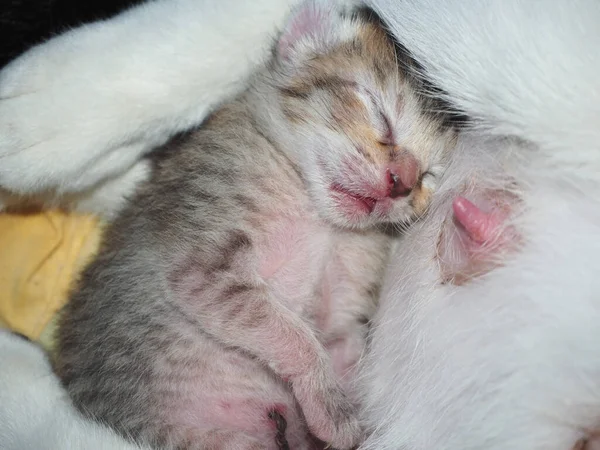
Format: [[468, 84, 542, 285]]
[[152, 324, 313, 450]]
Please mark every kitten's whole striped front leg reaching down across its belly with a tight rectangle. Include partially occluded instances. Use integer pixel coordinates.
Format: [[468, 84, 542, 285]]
[[169, 258, 361, 449]]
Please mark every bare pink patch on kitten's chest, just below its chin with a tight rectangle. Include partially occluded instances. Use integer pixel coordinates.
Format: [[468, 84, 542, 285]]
[[258, 218, 333, 317]]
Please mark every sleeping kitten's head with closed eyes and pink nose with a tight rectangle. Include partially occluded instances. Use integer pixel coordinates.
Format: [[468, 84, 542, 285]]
[[273, 3, 455, 228]]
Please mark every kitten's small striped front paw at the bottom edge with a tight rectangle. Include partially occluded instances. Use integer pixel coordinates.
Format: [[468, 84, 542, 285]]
[[292, 374, 362, 450]]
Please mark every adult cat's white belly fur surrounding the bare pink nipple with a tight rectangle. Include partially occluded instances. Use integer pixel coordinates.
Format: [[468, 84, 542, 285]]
[[356, 0, 600, 450]]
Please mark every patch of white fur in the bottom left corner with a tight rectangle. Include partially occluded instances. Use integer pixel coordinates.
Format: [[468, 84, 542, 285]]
[[0, 329, 149, 450]]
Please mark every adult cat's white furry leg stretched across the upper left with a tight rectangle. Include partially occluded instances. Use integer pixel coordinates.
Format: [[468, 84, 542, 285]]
[[0, 0, 294, 214]]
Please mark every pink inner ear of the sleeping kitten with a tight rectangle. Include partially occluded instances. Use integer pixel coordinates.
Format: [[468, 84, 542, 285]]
[[277, 3, 331, 59]]
